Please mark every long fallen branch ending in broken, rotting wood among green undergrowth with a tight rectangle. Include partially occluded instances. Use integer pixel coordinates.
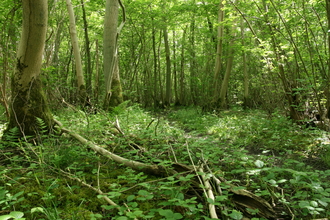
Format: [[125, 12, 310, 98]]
[[55, 120, 276, 219]]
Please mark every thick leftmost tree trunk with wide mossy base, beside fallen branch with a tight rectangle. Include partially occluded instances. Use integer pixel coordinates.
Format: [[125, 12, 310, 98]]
[[7, 0, 53, 135]]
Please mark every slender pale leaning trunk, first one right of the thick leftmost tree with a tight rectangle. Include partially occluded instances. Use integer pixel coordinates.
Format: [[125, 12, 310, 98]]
[[66, 0, 87, 104]]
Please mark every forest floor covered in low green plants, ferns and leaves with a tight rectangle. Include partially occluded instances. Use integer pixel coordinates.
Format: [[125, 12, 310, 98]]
[[0, 105, 330, 220]]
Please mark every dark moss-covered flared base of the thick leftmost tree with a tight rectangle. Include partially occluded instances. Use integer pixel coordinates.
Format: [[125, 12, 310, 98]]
[[7, 75, 54, 136]]
